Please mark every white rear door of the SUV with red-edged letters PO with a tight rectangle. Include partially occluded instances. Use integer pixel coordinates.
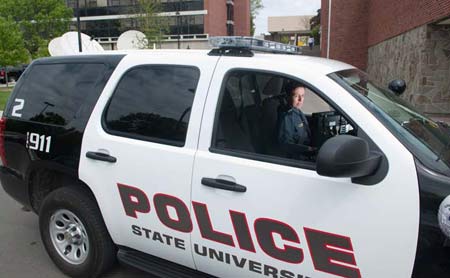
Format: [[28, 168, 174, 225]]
[[79, 54, 217, 268]]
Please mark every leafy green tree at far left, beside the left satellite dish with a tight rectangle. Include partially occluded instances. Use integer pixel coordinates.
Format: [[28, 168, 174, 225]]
[[0, 0, 73, 58]]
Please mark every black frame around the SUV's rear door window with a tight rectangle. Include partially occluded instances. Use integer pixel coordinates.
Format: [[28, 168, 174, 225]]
[[101, 64, 202, 148]]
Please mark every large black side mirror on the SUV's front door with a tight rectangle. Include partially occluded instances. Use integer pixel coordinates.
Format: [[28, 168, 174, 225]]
[[317, 135, 382, 178]]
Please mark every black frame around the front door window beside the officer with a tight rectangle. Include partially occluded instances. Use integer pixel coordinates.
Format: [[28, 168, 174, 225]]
[[208, 67, 364, 171]]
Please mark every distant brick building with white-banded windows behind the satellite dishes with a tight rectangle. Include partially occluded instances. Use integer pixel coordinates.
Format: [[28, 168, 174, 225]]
[[66, 0, 250, 49]]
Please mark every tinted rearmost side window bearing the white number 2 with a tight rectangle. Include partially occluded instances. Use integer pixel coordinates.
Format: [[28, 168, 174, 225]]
[[10, 63, 106, 126]]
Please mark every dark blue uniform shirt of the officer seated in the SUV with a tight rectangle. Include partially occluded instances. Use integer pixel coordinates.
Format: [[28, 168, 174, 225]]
[[278, 108, 311, 146]]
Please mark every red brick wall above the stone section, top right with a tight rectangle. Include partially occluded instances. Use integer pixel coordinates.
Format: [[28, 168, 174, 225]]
[[321, 0, 450, 69]]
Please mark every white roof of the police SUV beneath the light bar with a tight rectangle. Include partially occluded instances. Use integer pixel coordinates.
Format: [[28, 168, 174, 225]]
[[39, 49, 354, 75]]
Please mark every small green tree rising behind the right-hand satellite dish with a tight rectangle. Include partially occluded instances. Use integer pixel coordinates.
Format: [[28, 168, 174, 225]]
[[133, 0, 169, 48]]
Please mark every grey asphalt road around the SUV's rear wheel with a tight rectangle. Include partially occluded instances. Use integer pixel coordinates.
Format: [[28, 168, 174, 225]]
[[0, 186, 151, 278]]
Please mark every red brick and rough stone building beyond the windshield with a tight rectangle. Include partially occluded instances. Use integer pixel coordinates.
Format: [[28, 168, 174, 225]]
[[321, 0, 450, 118]]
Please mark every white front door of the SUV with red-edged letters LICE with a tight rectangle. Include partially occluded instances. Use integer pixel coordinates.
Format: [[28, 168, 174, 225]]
[[192, 57, 419, 278]]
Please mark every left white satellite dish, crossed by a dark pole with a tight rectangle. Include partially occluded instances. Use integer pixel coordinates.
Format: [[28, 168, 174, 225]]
[[48, 32, 105, 56]]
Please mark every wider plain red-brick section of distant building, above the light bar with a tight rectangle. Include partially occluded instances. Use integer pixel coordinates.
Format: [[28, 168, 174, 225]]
[[204, 0, 227, 36]]
